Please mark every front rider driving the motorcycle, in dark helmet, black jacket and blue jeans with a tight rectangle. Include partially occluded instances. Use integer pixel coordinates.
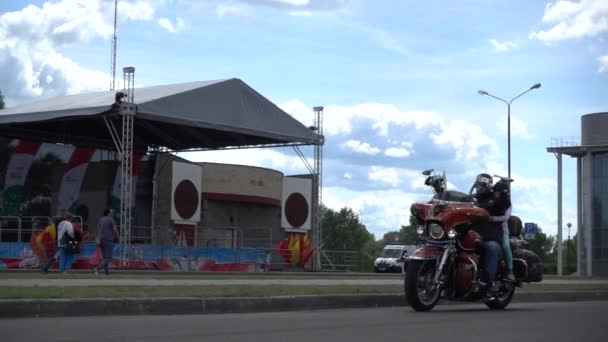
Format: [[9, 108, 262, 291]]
[[473, 173, 505, 296]]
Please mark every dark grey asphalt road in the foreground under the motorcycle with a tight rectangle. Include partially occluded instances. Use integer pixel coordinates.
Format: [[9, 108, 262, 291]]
[[0, 302, 608, 342]]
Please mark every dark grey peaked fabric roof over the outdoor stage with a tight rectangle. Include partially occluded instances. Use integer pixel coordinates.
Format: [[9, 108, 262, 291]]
[[0, 78, 322, 151]]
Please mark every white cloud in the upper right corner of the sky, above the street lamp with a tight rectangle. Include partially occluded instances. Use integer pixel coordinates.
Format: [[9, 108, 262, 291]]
[[529, 0, 608, 42]]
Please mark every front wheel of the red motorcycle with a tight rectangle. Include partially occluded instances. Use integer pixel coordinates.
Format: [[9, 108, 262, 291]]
[[404, 260, 441, 311]]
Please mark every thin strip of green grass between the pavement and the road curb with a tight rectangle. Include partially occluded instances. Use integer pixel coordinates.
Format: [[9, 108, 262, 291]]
[[0, 284, 608, 299]]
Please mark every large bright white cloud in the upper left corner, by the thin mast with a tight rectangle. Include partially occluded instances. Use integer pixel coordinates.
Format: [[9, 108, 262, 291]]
[[0, 0, 159, 105]]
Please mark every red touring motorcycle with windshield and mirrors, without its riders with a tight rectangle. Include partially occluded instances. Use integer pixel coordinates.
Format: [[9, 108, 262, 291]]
[[404, 169, 542, 311]]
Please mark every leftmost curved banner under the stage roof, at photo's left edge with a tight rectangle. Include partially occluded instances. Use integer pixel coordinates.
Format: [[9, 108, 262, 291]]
[[2, 140, 42, 216]]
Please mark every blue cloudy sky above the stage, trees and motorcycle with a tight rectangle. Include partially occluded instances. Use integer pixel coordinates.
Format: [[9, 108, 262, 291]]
[[0, 0, 608, 238]]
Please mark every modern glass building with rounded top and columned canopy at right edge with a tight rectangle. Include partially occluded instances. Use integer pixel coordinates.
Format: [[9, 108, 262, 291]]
[[547, 112, 608, 276]]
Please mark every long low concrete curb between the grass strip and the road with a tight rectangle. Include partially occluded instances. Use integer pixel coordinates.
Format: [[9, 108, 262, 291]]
[[0, 291, 608, 318]]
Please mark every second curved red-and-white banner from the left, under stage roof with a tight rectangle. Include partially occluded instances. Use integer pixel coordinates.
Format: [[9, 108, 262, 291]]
[[57, 147, 95, 213]]
